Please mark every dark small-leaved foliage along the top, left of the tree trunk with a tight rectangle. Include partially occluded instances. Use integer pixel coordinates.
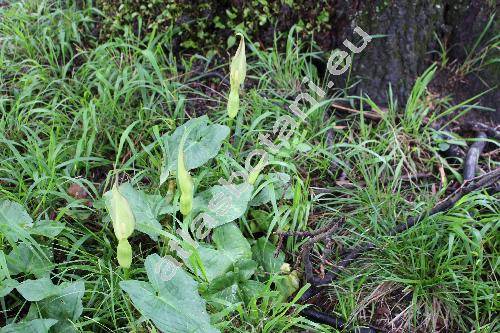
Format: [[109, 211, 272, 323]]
[[97, 0, 337, 50]]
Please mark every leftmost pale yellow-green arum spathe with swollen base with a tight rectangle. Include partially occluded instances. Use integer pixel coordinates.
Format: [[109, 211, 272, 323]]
[[108, 184, 135, 268]]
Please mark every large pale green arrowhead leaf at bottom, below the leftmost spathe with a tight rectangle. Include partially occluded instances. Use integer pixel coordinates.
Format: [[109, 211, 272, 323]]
[[120, 254, 219, 333]]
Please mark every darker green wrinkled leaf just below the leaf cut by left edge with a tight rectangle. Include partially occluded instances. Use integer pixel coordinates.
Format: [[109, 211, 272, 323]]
[[6, 243, 53, 278]]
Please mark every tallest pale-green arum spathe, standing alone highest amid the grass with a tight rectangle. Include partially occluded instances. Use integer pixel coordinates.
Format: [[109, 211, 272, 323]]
[[227, 34, 247, 119]]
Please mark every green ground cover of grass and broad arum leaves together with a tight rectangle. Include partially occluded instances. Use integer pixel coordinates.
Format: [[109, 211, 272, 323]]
[[0, 1, 500, 333]]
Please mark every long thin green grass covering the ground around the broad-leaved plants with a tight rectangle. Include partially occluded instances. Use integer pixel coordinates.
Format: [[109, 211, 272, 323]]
[[0, 1, 500, 332]]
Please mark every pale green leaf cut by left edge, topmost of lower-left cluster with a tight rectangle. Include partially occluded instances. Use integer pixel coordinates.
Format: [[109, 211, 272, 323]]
[[0, 200, 33, 243]]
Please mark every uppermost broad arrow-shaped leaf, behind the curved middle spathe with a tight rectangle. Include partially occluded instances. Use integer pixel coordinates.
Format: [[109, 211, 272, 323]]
[[161, 115, 229, 183]]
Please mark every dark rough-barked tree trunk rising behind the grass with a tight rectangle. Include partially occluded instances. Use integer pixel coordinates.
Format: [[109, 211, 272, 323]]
[[335, 0, 494, 105]]
